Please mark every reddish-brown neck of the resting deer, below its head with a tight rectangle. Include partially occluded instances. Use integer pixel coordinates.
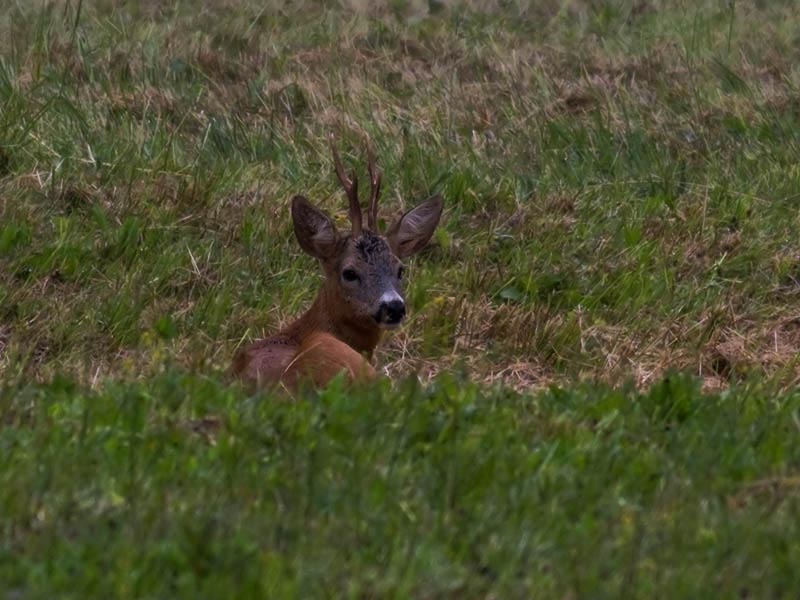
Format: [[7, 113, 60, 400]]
[[284, 285, 382, 357]]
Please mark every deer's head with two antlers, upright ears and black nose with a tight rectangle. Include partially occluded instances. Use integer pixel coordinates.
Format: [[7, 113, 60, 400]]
[[292, 138, 442, 329]]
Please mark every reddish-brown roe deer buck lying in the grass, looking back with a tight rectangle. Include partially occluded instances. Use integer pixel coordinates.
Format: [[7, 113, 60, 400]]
[[231, 135, 444, 391]]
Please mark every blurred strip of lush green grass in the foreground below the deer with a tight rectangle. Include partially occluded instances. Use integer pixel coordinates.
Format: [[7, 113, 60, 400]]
[[0, 374, 800, 598]]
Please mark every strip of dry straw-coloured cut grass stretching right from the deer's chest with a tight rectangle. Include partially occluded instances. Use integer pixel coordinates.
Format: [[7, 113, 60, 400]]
[[377, 292, 800, 391]]
